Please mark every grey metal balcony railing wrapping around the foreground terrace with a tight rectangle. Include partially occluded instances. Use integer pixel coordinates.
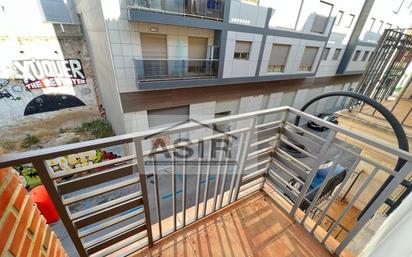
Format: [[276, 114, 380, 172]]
[[0, 107, 412, 256]]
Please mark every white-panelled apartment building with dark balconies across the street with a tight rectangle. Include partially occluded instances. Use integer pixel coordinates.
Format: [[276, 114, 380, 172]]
[[39, 0, 412, 138]]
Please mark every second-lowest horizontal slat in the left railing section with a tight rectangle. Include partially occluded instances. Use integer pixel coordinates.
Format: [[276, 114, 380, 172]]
[[73, 197, 143, 228]]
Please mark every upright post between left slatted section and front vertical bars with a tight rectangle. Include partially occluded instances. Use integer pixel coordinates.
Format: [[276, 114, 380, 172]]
[[133, 138, 154, 245]]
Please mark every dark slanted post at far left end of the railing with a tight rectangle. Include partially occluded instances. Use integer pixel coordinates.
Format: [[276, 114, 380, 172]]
[[32, 159, 88, 257]]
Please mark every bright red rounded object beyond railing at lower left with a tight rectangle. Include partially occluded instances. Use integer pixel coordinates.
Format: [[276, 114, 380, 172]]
[[30, 185, 59, 224]]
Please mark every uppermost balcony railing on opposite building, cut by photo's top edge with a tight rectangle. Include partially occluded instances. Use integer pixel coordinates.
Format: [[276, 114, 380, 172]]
[[129, 0, 224, 20]]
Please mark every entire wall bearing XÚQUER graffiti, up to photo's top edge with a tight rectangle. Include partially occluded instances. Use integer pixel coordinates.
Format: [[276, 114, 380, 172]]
[[0, 0, 100, 128]]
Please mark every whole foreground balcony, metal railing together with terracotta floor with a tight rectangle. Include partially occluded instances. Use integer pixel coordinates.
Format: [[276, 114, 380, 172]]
[[0, 107, 412, 256]]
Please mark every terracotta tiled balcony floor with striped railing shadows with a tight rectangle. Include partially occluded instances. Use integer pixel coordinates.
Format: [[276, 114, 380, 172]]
[[132, 192, 332, 257]]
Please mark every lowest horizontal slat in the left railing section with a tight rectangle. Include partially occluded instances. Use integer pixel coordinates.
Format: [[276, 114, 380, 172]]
[[84, 218, 146, 254]]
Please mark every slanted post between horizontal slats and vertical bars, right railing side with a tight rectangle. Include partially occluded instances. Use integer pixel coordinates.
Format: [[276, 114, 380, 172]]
[[290, 130, 336, 217]]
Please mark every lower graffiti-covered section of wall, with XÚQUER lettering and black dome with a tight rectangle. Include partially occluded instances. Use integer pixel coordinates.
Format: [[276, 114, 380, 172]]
[[0, 26, 98, 128]]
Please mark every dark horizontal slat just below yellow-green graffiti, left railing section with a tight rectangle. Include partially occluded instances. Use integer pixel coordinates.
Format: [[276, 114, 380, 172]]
[[57, 162, 136, 195]]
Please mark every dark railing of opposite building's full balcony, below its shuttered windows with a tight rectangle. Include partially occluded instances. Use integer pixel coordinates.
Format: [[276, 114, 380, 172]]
[[134, 59, 219, 81]]
